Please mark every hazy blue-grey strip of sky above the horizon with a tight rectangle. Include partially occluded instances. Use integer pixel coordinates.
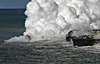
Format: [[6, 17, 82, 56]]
[[0, 0, 30, 8]]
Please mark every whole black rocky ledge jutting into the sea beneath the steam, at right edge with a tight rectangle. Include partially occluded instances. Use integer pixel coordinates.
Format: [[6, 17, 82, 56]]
[[66, 29, 100, 46]]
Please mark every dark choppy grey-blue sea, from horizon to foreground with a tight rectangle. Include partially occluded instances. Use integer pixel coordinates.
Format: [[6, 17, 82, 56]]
[[0, 9, 100, 64]]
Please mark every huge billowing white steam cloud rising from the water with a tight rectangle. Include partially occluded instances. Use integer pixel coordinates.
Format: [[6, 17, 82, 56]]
[[6, 0, 100, 42]]
